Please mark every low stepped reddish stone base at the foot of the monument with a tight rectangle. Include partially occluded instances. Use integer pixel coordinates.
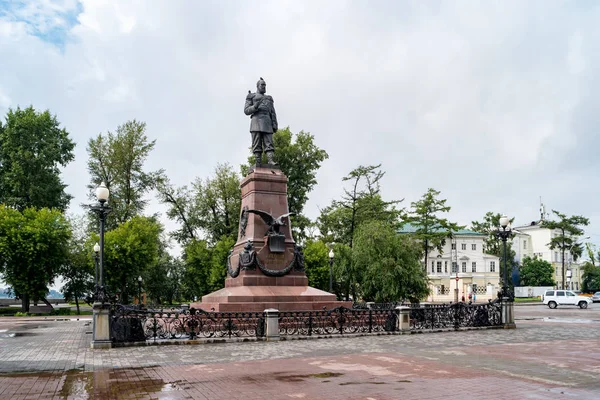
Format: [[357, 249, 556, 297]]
[[190, 286, 352, 312]]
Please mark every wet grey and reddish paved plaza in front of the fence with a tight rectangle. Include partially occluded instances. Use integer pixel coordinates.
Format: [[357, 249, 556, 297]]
[[0, 304, 600, 400]]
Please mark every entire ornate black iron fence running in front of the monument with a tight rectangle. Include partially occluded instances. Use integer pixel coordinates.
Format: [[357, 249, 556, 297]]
[[110, 300, 502, 343]]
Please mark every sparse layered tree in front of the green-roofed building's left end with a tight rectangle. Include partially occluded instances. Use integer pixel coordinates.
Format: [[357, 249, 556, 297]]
[[406, 188, 464, 266]]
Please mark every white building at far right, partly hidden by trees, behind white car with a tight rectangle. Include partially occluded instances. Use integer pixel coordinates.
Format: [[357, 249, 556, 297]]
[[512, 220, 583, 290]]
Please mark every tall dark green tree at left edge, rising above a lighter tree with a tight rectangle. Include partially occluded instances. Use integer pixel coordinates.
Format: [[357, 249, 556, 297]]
[[0, 106, 75, 211]]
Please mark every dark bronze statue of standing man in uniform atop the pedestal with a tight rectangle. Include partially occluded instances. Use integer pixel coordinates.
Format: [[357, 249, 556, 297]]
[[244, 78, 277, 165]]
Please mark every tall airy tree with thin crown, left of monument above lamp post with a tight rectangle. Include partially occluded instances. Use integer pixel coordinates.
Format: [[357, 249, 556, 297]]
[[87, 120, 164, 229]]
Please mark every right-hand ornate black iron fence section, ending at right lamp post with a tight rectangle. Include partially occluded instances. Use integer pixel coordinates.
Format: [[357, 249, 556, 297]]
[[410, 301, 502, 330]]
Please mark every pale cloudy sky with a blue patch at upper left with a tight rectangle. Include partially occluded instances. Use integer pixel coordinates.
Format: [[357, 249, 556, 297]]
[[0, 0, 600, 253]]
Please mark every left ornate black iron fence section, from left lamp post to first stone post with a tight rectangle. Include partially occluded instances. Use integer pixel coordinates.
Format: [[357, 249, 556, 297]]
[[110, 305, 265, 343]]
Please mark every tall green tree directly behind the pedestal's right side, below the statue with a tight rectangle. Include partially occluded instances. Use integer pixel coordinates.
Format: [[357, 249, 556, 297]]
[[241, 127, 329, 241]]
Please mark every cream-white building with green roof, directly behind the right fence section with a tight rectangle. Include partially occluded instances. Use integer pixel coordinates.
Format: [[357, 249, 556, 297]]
[[400, 225, 500, 302]]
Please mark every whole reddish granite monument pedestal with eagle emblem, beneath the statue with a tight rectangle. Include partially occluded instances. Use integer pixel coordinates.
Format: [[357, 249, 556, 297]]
[[191, 166, 350, 312]]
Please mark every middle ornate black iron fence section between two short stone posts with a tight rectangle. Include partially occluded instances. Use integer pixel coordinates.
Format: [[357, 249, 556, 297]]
[[279, 307, 398, 336]]
